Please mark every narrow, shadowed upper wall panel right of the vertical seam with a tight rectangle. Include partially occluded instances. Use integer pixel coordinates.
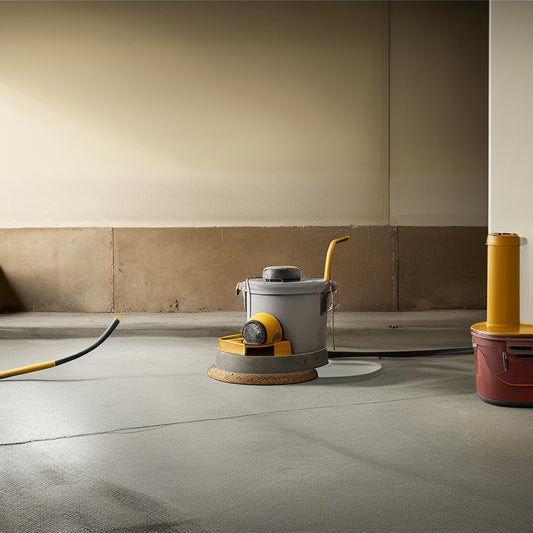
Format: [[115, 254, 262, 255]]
[[390, 1, 488, 226]]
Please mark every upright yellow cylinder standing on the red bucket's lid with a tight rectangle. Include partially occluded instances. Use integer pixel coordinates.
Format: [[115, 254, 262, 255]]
[[487, 233, 520, 326]]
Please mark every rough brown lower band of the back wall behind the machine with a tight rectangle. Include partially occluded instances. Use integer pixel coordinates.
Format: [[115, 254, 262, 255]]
[[0, 226, 487, 313]]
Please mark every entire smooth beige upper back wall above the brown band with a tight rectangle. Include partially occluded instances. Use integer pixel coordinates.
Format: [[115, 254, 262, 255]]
[[0, 1, 487, 227]]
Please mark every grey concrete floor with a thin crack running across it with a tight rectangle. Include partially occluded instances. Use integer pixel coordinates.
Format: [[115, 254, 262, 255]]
[[0, 311, 533, 533]]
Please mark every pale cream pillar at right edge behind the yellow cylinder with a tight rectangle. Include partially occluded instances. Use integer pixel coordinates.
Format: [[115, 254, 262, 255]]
[[489, 1, 533, 323]]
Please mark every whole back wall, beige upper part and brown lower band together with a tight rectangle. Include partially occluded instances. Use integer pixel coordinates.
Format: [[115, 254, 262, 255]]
[[0, 1, 487, 312]]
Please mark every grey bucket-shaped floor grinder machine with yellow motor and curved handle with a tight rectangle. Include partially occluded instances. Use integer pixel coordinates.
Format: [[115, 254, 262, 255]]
[[207, 235, 349, 385]]
